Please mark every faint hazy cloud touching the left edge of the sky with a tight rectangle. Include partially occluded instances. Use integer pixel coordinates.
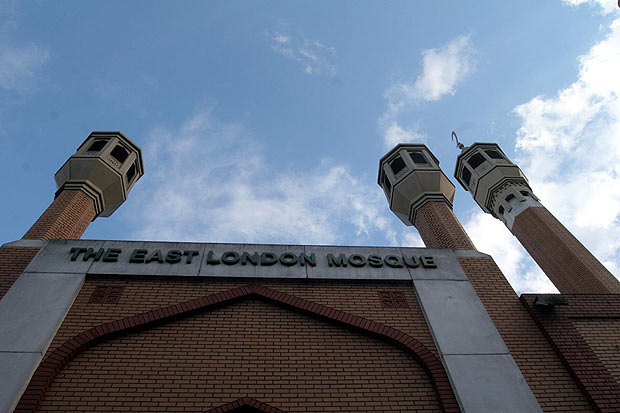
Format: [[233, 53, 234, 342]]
[[0, 45, 50, 92]]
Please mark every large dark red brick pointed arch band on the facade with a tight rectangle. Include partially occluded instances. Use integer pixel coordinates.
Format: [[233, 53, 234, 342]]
[[14, 284, 461, 413]]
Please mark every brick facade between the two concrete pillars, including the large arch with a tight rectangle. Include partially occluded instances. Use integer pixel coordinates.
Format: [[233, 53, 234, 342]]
[[16, 279, 459, 412]]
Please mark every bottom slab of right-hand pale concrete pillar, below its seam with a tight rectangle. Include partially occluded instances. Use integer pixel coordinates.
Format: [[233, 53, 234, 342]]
[[443, 354, 542, 413]]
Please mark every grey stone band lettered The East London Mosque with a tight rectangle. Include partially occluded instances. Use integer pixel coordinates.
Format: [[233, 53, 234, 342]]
[[26, 240, 465, 280]]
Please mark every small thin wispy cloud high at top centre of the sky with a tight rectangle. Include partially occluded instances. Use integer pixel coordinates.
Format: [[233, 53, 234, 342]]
[[269, 24, 337, 77]]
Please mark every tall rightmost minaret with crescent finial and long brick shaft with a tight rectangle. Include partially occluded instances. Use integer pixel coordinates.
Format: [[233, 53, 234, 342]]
[[454, 143, 620, 294]]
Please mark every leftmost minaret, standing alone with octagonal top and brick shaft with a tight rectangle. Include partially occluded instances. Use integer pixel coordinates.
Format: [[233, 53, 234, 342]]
[[23, 132, 144, 241]]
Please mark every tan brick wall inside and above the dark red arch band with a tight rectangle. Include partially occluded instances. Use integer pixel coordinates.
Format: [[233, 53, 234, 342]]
[[32, 278, 441, 411]]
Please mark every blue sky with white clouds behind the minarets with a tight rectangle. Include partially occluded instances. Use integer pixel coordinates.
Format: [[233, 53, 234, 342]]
[[0, 0, 620, 291]]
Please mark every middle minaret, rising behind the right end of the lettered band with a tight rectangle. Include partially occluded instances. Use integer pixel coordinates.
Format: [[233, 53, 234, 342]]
[[378, 143, 476, 250]]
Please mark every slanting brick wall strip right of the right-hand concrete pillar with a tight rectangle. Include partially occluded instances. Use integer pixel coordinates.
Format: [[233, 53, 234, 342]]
[[459, 257, 594, 412]]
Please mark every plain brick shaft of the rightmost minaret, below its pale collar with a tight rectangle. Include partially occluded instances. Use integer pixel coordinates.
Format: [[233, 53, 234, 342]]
[[512, 207, 620, 294]]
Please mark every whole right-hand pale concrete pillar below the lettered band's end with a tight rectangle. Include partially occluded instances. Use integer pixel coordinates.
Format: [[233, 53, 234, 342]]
[[413, 279, 542, 413]]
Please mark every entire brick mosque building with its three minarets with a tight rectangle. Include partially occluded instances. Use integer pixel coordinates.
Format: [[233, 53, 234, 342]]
[[0, 132, 620, 413]]
